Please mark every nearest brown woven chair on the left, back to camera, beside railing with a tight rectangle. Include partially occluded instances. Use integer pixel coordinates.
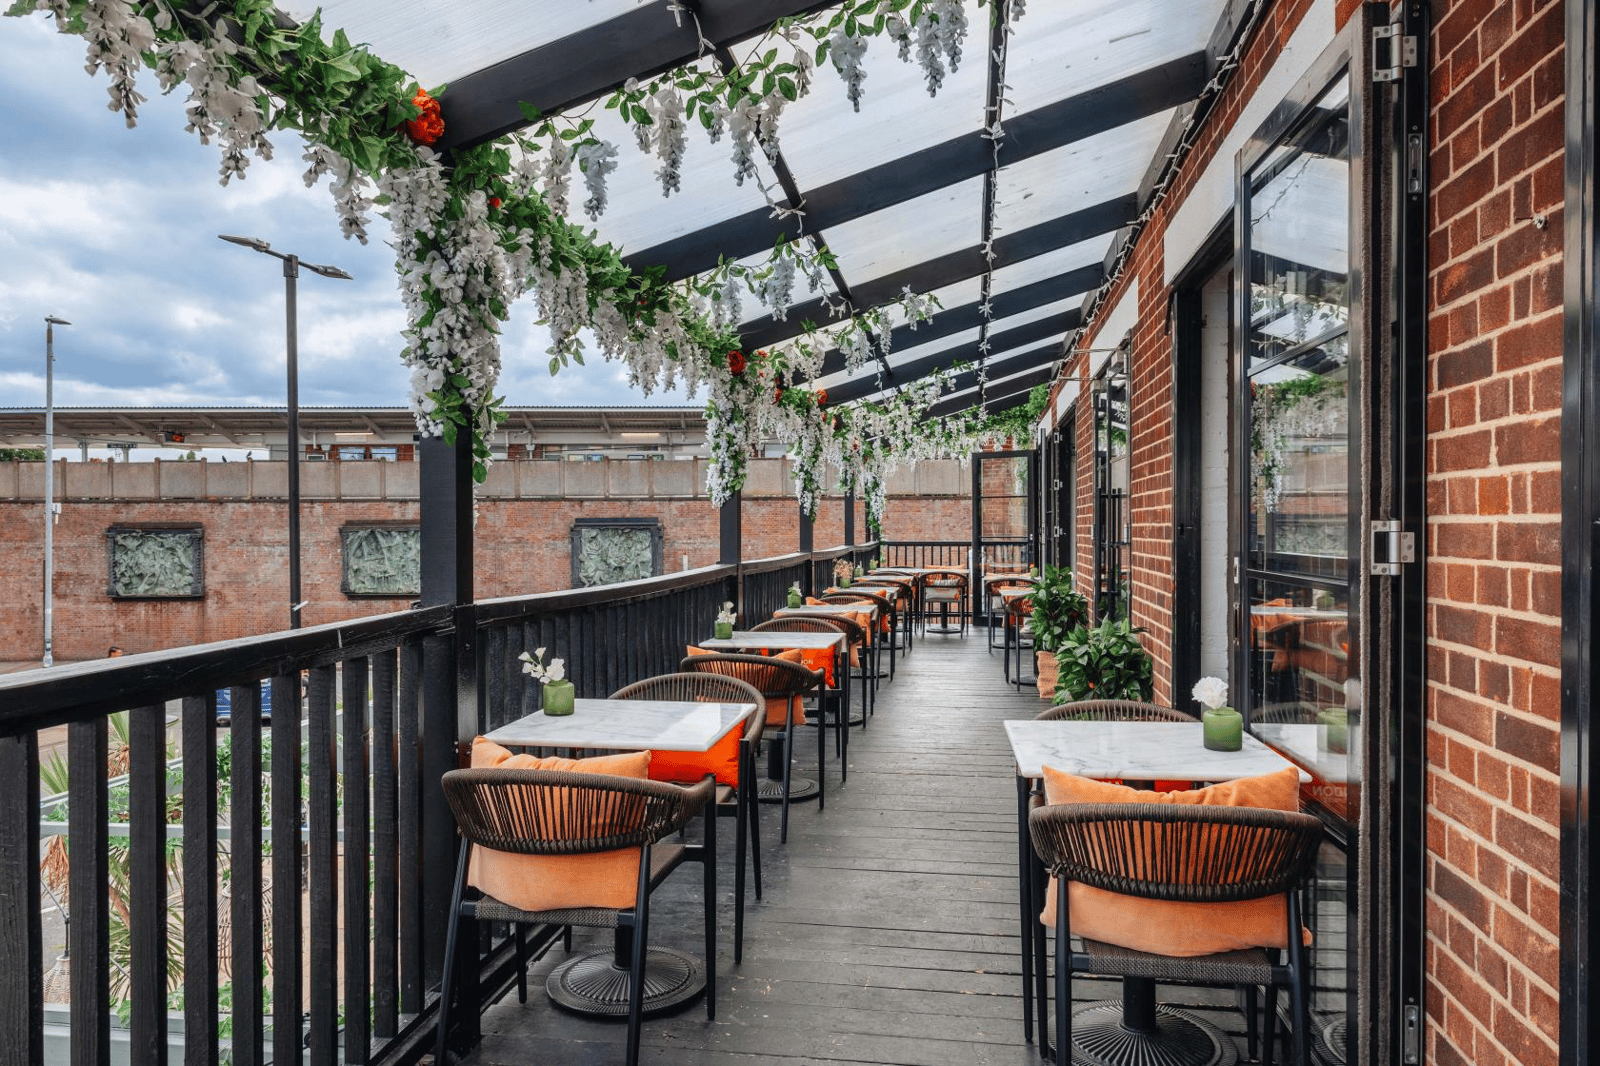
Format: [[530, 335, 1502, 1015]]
[[434, 768, 717, 1066]]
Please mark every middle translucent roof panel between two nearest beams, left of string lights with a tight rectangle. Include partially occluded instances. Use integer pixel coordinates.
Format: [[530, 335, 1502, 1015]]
[[778, 28, 989, 190]]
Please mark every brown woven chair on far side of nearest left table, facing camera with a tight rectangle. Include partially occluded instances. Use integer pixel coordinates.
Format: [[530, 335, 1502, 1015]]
[[611, 672, 766, 962]]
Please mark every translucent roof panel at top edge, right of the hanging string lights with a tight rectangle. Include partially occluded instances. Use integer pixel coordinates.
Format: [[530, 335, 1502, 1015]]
[[1005, 0, 1227, 115]]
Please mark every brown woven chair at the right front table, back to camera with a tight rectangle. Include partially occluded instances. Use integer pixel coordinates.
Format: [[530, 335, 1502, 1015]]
[[1029, 804, 1323, 1066]]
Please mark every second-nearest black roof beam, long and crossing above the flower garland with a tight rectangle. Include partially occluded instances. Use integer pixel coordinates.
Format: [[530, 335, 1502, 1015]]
[[624, 53, 1205, 280]]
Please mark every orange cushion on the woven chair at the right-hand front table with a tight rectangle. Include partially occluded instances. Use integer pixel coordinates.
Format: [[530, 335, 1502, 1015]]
[[1038, 767, 1310, 957]]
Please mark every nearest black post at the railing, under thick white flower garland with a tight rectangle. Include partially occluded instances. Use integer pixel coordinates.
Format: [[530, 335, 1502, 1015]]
[[418, 434, 478, 1034]]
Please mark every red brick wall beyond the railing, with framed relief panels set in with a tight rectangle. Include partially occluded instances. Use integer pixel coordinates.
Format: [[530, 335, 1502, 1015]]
[[0, 480, 971, 663]]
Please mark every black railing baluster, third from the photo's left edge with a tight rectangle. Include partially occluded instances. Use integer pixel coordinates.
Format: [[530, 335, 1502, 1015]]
[[130, 704, 166, 1066]]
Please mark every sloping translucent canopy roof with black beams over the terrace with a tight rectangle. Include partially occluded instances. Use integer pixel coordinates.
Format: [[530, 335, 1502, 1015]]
[[265, 0, 1250, 413]]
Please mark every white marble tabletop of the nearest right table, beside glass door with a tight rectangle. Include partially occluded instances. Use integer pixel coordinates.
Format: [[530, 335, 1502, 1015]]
[[1005, 719, 1310, 781]]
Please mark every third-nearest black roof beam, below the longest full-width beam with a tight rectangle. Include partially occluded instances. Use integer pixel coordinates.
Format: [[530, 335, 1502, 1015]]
[[739, 195, 1136, 351]]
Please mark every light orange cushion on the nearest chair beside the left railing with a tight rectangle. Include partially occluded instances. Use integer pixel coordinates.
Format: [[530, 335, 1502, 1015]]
[[467, 736, 650, 911]]
